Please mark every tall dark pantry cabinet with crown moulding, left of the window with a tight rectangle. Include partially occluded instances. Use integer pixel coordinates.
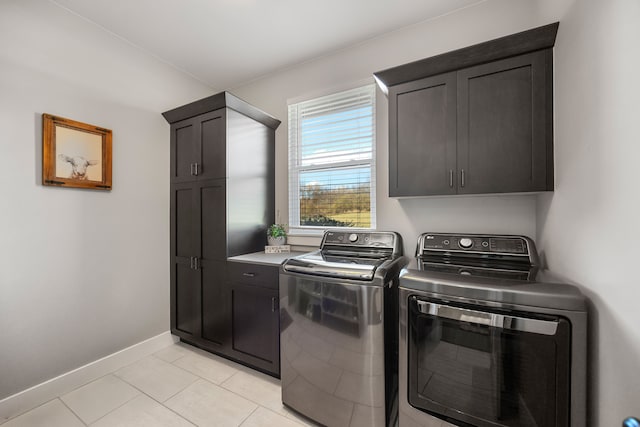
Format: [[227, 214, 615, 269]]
[[163, 92, 280, 372]]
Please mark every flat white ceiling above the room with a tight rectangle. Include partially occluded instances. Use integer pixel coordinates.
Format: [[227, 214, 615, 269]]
[[51, 0, 484, 90]]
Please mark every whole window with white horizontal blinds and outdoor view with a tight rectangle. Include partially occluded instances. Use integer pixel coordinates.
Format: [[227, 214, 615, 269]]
[[289, 84, 376, 230]]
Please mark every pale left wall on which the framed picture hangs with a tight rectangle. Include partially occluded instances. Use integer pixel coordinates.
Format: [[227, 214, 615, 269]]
[[0, 0, 211, 400]]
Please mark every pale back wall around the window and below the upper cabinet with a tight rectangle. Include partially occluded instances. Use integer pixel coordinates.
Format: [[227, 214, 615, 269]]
[[232, 0, 568, 264]]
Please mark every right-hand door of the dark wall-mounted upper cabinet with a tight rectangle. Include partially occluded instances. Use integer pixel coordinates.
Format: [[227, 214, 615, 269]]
[[458, 50, 553, 194]]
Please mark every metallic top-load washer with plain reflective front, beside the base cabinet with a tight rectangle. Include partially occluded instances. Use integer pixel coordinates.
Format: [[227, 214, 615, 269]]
[[280, 231, 407, 427]]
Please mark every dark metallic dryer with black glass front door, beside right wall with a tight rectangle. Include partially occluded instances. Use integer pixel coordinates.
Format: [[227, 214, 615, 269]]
[[399, 233, 587, 427]]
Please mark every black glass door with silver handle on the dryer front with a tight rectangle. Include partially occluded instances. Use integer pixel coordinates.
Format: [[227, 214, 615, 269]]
[[408, 297, 571, 427]]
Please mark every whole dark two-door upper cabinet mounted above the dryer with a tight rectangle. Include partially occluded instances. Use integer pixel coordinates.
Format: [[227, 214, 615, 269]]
[[375, 23, 558, 197]]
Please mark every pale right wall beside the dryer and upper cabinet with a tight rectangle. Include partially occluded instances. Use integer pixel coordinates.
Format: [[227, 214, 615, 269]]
[[537, 0, 640, 427]]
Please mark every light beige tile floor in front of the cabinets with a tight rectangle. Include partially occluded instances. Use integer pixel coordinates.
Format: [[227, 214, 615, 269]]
[[0, 343, 313, 427]]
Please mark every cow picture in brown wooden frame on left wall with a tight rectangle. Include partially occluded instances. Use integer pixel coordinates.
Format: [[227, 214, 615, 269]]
[[42, 114, 111, 190]]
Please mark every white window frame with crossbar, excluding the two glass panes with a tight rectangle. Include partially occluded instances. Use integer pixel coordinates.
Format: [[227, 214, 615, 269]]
[[287, 81, 377, 236]]
